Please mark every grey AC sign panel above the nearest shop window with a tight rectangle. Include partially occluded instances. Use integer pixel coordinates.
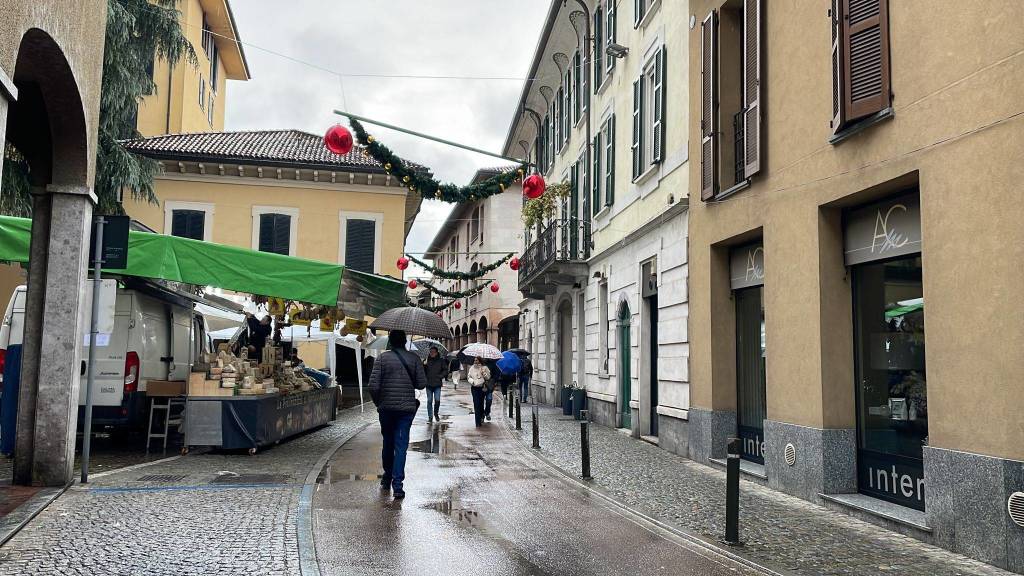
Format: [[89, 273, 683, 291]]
[[846, 192, 921, 265]]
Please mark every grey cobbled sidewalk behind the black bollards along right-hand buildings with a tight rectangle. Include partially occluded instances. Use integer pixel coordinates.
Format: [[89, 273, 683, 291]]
[[505, 397, 1011, 576]]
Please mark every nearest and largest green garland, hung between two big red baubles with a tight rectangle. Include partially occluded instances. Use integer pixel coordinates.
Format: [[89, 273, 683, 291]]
[[349, 118, 528, 203]]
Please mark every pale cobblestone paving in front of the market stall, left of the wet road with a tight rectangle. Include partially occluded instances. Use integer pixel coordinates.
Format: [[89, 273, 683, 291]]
[[0, 408, 376, 576]]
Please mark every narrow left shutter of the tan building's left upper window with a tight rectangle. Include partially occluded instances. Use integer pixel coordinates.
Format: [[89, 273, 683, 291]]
[[700, 10, 718, 200]]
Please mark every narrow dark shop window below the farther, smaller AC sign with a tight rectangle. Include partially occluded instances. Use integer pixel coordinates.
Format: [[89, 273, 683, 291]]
[[734, 286, 767, 464]]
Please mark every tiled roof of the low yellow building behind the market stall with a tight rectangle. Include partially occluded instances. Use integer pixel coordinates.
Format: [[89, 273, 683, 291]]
[[124, 130, 415, 172]]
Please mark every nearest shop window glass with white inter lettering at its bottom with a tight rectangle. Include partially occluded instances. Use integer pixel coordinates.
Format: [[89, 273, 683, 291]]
[[853, 255, 928, 510]]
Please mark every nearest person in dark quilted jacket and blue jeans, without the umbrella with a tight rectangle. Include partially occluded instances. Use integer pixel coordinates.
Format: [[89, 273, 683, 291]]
[[370, 330, 427, 499]]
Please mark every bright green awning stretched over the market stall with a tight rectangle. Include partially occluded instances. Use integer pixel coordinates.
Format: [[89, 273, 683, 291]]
[[0, 216, 406, 318]]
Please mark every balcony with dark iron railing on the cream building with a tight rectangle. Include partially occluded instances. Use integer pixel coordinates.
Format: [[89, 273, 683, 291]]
[[519, 217, 591, 299]]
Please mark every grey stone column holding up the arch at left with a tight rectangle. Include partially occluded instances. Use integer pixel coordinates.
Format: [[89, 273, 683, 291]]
[[14, 186, 94, 486]]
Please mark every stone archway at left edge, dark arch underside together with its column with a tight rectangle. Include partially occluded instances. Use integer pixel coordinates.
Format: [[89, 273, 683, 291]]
[[0, 26, 103, 486]]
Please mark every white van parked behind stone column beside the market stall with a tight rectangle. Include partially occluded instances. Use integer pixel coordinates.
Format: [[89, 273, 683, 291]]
[[0, 283, 210, 430]]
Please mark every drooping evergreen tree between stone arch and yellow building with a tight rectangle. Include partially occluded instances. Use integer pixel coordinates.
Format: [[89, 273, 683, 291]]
[[95, 0, 199, 213]]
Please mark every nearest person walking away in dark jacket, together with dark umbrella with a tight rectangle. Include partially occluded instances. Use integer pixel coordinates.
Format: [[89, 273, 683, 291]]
[[370, 306, 452, 499]]
